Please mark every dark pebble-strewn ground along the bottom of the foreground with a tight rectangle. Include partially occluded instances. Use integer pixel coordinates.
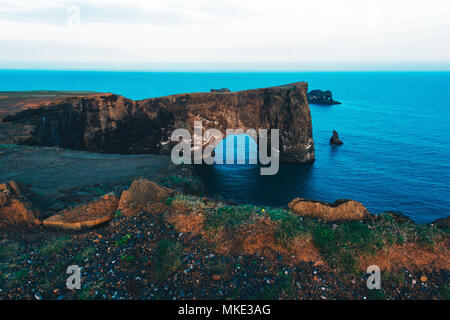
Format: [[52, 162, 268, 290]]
[[0, 201, 449, 299]]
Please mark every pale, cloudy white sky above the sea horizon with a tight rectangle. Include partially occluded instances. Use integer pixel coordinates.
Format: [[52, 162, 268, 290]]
[[0, 0, 450, 71]]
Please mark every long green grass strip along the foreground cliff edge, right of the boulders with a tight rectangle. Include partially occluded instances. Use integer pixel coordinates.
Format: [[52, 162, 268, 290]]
[[167, 195, 447, 275]]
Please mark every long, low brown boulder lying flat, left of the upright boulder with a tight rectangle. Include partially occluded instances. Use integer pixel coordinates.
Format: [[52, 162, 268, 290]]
[[42, 194, 119, 230]]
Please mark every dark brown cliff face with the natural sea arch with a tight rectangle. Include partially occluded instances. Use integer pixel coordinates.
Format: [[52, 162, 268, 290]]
[[4, 82, 314, 162]]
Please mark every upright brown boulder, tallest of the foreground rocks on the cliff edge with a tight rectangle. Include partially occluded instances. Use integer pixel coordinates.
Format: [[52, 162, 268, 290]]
[[118, 179, 175, 216]]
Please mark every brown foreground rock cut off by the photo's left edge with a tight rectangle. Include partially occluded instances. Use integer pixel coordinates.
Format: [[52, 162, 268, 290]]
[[0, 181, 40, 227]]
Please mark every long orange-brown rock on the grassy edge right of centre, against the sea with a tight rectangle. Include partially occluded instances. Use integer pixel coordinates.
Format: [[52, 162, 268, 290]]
[[288, 198, 370, 221]]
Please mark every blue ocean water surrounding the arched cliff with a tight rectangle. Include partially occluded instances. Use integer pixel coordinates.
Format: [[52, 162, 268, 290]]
[[0, 71, 450, 222]]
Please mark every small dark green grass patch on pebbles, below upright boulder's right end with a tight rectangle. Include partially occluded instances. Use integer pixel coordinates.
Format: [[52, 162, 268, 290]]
[[156, 240, 183, 278]]
